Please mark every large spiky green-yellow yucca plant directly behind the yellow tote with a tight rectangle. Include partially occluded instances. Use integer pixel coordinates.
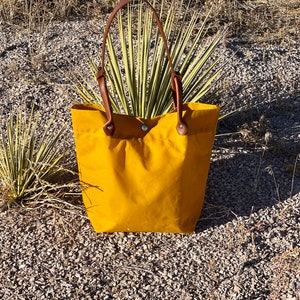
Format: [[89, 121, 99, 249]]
[[76, 1, 224, 118]]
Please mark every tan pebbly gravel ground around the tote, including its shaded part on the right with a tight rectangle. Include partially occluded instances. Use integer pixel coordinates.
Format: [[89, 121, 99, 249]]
[[0, 14, 300, 300]]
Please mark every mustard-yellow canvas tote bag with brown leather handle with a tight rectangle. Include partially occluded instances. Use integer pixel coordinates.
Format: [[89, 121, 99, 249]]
[[71, 0, 219, 233]]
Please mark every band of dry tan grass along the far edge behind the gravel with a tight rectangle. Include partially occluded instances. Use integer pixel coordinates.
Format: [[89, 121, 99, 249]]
[[0, 0, 300, 44]]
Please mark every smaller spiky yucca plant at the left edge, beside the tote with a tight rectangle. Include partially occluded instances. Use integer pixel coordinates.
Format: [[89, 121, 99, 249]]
[[0, 109, 65, 209]]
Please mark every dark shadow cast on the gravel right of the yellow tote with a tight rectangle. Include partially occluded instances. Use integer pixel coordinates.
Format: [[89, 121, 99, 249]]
[[197, 96, 300, 232]]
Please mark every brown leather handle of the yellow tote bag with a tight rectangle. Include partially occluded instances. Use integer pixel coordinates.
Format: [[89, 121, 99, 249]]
[[96, 0, 188, 135]]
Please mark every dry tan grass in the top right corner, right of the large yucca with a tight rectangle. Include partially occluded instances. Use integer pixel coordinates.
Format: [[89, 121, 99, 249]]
[[200, 0, 300, 43]]
